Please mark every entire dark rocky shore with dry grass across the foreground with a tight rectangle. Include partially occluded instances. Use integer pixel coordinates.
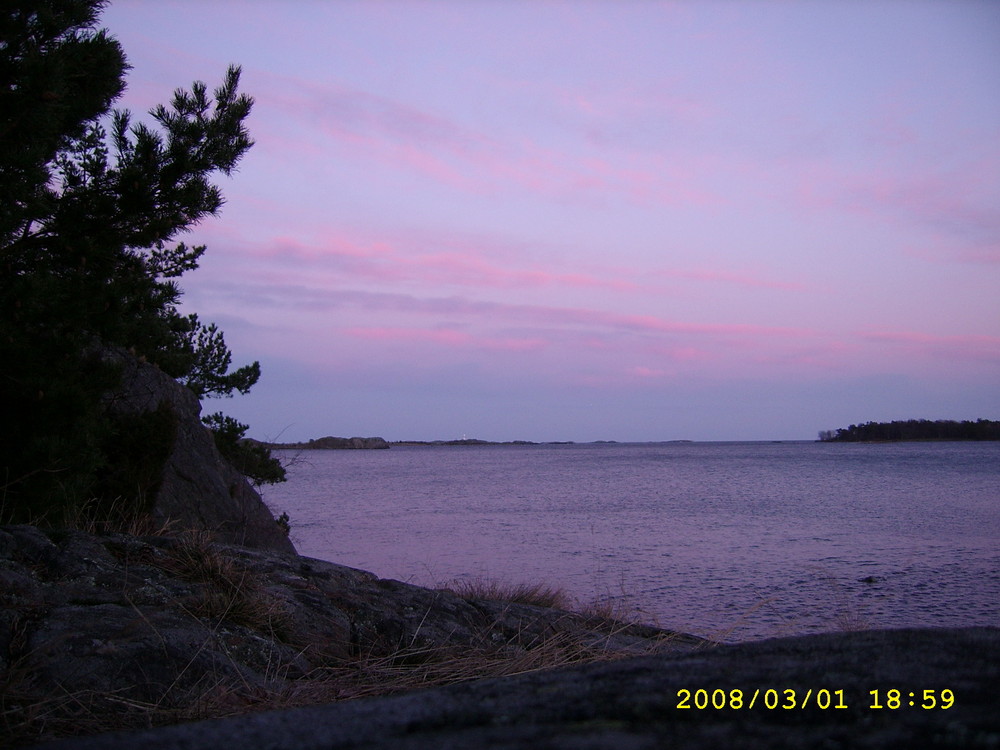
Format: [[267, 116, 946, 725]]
[[0, 526, 1000, 750]]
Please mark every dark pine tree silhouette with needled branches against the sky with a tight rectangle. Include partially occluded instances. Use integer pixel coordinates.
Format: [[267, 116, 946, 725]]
[[0, 0, 280, 519]]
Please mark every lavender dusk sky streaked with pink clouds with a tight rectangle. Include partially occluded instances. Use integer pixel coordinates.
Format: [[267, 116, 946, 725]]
[[95, 0, 1000, 442]]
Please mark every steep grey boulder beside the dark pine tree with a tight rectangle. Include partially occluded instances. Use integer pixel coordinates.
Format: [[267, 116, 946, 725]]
[[106, 351, 295, 553]]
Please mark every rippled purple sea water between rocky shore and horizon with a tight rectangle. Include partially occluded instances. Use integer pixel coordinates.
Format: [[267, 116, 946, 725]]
[[265, 443, 1000, 640]]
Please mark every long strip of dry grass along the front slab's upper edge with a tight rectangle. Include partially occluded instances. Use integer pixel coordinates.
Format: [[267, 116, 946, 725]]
[[0, 596, 636, 747]]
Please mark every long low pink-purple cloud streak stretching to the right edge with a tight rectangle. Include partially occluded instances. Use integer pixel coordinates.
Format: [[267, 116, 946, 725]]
[[199, 272, 1000, 385]]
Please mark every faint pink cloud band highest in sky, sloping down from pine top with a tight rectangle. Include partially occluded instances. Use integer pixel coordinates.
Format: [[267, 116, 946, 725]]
[[254, 72, 718, 205]]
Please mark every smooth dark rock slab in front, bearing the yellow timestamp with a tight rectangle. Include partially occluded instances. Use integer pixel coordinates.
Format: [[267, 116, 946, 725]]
[[41, 628, 1000, 750]]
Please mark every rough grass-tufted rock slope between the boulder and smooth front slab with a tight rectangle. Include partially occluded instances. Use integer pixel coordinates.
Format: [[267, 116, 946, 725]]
[[0, 526, 703, 744]]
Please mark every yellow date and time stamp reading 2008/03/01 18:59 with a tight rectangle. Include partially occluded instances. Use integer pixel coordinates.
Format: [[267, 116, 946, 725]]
[[676, 688, 955, 711]]
